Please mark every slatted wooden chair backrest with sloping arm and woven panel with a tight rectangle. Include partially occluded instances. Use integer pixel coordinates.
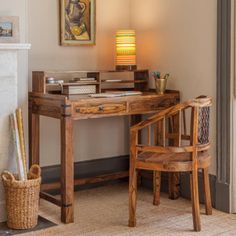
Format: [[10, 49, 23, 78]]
[[131, 96, 212, 148]]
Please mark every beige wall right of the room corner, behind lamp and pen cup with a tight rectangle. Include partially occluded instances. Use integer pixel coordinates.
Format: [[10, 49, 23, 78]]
[[131, 0, 217, 173]]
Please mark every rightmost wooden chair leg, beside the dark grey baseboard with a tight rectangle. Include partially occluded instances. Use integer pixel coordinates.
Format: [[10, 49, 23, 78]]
[[202, 168, 212, 215]]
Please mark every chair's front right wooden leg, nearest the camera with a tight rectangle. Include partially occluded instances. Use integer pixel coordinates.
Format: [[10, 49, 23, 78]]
[[190, 170, 201, 232]]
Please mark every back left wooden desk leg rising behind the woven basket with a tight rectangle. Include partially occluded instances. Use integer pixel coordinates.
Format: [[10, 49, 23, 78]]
[[29, 109, 40, 167]]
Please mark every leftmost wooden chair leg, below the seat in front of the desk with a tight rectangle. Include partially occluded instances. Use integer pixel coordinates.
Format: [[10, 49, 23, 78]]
[[129, 168, 137, 227]]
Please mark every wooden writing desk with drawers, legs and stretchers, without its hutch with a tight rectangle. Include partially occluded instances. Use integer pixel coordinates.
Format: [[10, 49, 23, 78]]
[[29, 91, 179, 223]]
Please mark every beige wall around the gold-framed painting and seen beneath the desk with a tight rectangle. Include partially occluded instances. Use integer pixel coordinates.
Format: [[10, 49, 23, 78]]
[[28, 0, 130, 165]]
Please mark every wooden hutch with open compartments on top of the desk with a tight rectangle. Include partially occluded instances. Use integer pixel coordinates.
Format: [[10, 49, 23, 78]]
[[33, 70, 149, 94]]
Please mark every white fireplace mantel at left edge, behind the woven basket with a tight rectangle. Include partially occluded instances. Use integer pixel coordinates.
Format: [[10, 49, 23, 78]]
[[0, 43, 31, 222]]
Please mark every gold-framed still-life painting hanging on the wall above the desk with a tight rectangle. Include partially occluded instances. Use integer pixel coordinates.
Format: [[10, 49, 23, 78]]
[[59, 0, 96, 46]]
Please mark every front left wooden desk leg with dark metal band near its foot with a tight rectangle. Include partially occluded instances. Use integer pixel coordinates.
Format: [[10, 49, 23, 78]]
[[61, 117, 74, 224]]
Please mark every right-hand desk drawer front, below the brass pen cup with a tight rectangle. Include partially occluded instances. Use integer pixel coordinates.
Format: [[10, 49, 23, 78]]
[[129, 98, 176, 113]]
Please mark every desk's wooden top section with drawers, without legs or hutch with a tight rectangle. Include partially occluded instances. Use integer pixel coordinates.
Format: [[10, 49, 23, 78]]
[[29, 90, 180, 120]]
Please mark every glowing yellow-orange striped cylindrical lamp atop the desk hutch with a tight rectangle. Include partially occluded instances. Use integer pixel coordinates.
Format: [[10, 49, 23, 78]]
[[116, 30, 137, 70]]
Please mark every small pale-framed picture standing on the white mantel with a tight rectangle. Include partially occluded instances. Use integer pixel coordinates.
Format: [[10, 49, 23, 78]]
[[0, 16, 20, 43]]
